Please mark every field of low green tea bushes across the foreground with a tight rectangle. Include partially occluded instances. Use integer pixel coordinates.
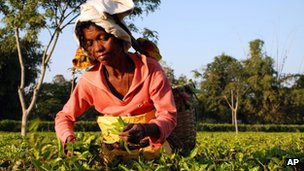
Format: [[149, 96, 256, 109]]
[[0, 132, 304, 171]]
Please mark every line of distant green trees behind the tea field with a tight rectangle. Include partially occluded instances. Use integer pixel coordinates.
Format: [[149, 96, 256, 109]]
[[0, 39, 304, 123]]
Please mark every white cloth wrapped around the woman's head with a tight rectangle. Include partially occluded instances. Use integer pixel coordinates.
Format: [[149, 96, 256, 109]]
[[74, 0, 134, 52]]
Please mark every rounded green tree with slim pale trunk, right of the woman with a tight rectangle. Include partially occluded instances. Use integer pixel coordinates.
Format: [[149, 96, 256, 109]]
[[196, 54, 244, 132]]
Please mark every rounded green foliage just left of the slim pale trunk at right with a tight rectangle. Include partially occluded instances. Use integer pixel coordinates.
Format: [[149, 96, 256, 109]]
[[196, 54, 244, 122]]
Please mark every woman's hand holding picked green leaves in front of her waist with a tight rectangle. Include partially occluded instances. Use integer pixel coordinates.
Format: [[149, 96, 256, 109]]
[[119, 124, 146, 144]]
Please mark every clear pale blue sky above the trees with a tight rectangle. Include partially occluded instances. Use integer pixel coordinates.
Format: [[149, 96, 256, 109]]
[[41, 0, 304, 82]]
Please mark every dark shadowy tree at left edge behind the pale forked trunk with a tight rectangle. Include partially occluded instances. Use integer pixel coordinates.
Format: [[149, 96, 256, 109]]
[[0, 28, 42, 120]]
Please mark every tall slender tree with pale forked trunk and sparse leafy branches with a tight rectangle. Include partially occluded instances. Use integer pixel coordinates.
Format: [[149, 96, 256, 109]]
[[0, 0, 160, 136]]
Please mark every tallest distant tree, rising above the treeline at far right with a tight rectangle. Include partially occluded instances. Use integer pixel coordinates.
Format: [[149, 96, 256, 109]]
[[243, 39, 282, 123]]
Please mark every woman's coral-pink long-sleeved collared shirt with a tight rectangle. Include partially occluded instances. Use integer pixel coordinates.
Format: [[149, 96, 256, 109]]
[[55, 53, 176, 143]]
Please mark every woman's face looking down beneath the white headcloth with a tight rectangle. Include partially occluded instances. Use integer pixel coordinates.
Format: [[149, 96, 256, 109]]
[[83, 25, 124, 65]]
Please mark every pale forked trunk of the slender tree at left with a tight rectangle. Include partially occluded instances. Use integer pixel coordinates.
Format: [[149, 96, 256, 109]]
[[11, 0, 81, 136]]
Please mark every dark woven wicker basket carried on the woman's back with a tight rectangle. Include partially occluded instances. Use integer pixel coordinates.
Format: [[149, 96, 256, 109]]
[[167, 84, 196, 152]]
